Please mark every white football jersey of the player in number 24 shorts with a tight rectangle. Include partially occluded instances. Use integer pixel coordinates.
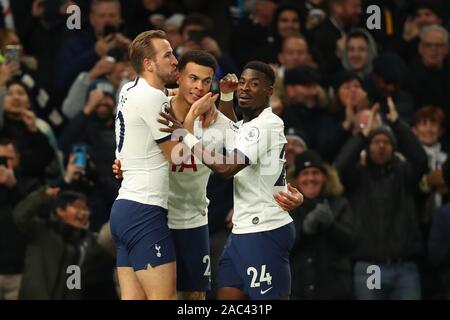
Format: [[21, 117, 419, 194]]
[[229, 107, 292, 234]]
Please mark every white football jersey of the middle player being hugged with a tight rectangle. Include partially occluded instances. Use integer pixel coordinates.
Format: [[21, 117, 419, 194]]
[[168, 106, 233, 229]]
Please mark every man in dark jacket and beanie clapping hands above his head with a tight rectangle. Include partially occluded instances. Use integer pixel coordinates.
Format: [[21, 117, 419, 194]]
[[335, 98, 427, 299]]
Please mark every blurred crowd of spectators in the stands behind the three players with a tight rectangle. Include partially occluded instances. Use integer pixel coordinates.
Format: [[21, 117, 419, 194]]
[[0, 0, 450, 300]]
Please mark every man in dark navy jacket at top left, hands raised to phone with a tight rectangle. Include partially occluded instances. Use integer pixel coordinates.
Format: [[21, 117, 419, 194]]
[[56, 0, 131, 92]]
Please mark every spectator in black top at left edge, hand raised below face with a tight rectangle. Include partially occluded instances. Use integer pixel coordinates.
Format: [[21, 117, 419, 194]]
[[0, 81, 55, 182]]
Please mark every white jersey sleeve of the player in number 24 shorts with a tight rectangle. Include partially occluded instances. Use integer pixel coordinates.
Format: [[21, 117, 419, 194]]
[[235, 119, 283, 164]]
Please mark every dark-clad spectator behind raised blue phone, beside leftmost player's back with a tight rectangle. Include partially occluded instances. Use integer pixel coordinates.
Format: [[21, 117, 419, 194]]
[[59, 84, 119, 230]]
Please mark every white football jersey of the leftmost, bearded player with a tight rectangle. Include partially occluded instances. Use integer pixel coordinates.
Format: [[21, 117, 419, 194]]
[[116, 77, 171, 209]]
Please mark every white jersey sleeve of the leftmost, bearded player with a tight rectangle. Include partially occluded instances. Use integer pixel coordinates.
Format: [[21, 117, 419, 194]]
[[137, 91, 171, 143]]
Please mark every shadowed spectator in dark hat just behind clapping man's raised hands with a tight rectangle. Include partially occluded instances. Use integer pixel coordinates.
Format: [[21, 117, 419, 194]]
[[365, 53, 414, 123]]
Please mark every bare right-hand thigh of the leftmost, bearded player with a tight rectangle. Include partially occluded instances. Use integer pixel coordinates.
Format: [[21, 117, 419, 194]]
[[136, 262, 177, 300]]
